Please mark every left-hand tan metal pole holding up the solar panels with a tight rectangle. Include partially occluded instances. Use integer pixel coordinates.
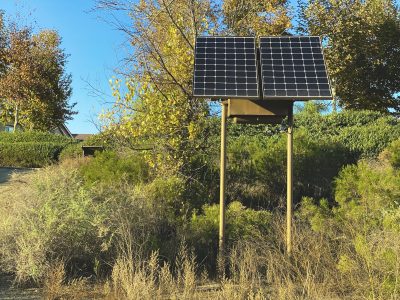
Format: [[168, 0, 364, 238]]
[[218, 102, 228, 277]]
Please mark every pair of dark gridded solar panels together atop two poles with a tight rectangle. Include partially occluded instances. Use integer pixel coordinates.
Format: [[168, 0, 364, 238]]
[[193, 36, 332, 100]]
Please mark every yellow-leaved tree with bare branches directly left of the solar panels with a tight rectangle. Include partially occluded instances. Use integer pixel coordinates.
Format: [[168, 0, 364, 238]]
[[98, 0, 216, 171]]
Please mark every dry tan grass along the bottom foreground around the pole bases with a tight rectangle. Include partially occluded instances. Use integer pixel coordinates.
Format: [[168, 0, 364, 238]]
[[39, 219, 400, 300]]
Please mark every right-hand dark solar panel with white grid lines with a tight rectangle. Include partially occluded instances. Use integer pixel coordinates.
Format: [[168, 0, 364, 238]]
[[260, 36, 332, 100]]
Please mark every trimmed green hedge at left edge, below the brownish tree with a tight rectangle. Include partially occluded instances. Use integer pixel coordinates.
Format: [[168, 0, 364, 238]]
[[0, 142, 67, 168]]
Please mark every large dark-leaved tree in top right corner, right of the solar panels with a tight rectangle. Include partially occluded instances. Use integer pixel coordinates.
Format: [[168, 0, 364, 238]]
[[300, 0, 400, 114]]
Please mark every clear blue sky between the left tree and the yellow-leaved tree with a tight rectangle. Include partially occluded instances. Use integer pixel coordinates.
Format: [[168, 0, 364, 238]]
[[0, 0, 130, 133]]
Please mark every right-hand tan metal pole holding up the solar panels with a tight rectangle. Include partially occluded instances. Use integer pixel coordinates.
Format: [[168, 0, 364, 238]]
[[286, 103, 293, 255]]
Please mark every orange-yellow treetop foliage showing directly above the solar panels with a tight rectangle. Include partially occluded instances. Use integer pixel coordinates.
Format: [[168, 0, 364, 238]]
[[223, 0, 291, 36]]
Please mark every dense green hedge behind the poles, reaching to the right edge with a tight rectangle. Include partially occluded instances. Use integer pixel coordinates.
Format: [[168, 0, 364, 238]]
[[217, 103, 400, 209]]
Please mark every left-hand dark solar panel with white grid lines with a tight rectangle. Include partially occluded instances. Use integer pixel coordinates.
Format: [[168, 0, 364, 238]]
[[193, 37, 259, 99]]
